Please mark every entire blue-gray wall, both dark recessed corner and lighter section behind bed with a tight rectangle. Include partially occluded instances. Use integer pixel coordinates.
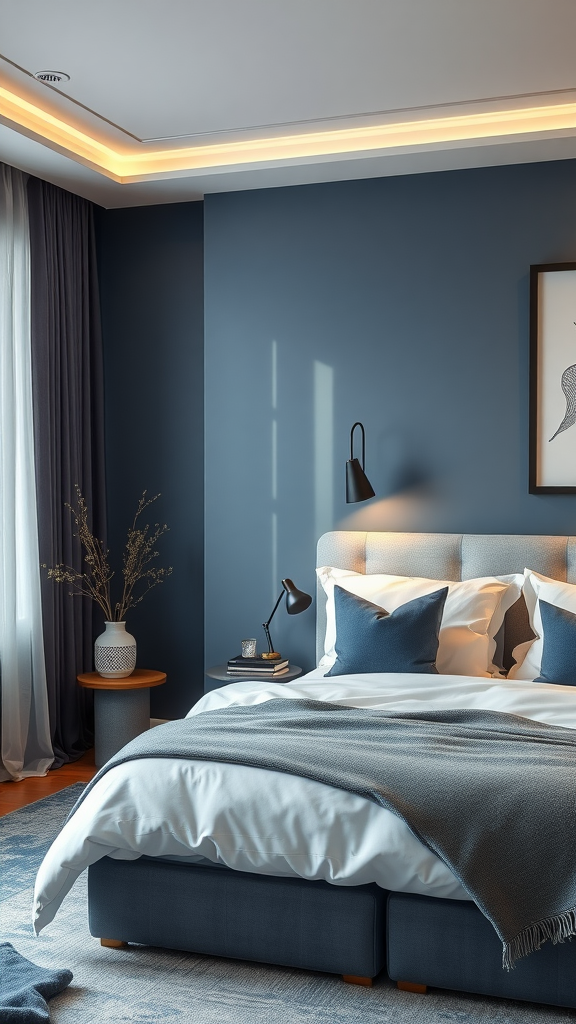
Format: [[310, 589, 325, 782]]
[[94, 161, 576, 704]]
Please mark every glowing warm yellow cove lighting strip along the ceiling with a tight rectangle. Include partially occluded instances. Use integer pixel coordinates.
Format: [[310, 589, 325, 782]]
[[0, 87, 576, 184]]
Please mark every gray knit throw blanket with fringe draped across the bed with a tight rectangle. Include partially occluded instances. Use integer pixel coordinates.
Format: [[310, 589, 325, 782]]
[[72, 698, 576, 969]]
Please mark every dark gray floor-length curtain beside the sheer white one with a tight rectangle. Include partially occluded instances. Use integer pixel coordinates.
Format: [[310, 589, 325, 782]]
[[28, 178, 106, 767]]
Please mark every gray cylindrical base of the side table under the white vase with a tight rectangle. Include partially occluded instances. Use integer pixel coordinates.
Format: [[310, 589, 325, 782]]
[[94, 687, 150, 768]]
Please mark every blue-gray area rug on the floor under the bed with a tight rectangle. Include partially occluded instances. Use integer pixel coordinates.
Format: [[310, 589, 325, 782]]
[[0, 784, 576, 1024]]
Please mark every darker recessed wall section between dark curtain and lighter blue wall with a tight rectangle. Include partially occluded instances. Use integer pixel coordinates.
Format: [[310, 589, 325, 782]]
[[96, 197, 204, 718]]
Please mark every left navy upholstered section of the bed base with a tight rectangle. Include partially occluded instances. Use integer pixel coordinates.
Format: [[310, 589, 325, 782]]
[[88, 857, 387, 978]]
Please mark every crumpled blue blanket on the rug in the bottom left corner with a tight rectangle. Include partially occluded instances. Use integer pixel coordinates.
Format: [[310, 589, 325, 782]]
[[0, 942, 72, 1024]]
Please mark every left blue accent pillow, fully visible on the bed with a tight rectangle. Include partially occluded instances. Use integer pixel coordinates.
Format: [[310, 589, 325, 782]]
[[326, 586, 448, 676]]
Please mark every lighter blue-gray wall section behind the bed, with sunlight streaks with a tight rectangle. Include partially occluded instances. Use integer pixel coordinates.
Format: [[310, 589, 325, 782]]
[[202, 162, 576, 668]]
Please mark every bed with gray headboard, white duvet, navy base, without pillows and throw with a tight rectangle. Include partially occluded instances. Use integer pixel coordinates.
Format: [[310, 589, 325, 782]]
[[35, 531, 576, 1007]]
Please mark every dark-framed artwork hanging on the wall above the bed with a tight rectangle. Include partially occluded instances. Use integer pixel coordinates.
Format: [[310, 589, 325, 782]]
[[529, 262, 576, 495]]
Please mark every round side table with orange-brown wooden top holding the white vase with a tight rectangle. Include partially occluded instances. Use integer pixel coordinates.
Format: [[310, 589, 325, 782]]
[[77, 669, 166, 768]]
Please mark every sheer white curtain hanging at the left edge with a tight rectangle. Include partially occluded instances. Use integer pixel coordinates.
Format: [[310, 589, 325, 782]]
[[0, 164, 53, 780]]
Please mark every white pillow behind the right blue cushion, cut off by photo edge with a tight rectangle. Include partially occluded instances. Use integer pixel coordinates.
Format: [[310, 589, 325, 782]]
[[508, 569, 576, 679]]
